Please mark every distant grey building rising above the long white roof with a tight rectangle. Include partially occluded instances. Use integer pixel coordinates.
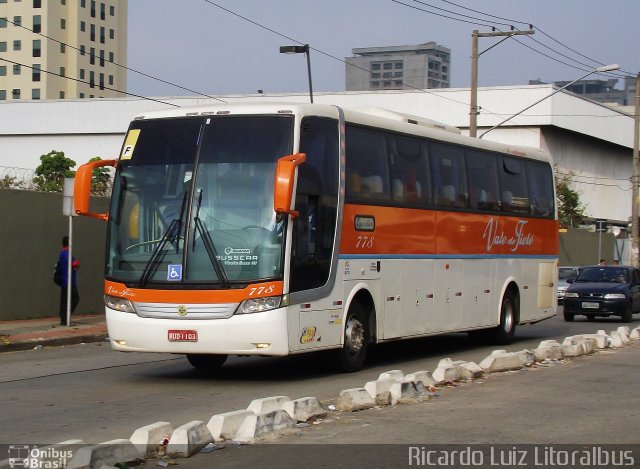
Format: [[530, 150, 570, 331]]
[[345, 41, 451, 91]]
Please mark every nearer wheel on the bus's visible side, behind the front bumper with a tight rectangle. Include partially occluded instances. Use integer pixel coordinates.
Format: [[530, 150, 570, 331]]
[[338, 302, 369, 373]]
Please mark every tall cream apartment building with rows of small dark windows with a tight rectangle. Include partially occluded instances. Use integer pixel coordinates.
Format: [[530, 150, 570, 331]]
[[0, 0, 128, 101]]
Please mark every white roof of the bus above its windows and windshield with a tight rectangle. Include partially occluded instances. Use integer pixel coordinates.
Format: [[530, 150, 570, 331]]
[[134, 101, 552, 163]]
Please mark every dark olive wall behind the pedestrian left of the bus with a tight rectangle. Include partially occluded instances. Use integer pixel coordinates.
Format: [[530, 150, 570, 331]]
[[0, 189, 108, 320]]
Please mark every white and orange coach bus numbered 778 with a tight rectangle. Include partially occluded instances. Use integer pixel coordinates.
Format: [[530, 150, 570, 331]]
[[75, 103, 558, 371]]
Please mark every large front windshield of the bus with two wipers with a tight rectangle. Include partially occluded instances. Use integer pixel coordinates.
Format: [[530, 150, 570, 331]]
[[107, 116, 294, 288]]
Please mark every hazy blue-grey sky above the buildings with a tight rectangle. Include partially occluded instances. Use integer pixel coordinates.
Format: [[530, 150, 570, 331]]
[[127, 0, 640, 96]]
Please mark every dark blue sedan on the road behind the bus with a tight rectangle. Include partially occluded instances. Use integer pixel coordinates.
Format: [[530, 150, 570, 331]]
[[564, 265, 640, 322]]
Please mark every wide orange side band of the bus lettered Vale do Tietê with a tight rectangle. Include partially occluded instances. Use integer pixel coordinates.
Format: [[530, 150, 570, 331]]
[[340, 204, 558, 256]]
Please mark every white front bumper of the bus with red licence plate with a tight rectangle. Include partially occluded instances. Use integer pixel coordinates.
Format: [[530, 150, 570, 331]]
[[106, 308, 289, 355]]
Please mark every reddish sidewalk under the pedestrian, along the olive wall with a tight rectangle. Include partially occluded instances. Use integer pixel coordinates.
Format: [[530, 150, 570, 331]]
[[0, 314, 108, 353]]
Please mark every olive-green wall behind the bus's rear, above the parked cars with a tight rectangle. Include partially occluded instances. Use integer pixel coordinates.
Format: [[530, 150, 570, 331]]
[[560, 228, 625, 265]]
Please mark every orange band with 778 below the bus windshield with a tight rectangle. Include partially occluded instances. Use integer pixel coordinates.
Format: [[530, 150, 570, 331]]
[[104, 280, 283, 303]]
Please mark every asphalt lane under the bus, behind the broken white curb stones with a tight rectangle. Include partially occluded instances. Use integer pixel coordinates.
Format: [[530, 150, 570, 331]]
[[0, 308, 640, 445]]
